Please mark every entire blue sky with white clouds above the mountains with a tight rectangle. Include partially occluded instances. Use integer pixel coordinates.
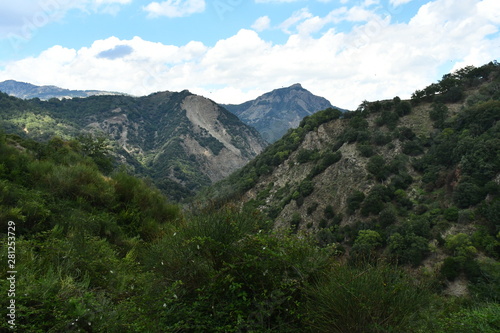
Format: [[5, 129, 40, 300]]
[[0, 0, 500, 109]]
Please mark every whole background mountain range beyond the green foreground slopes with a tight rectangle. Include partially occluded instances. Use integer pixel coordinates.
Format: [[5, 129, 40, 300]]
[[0, 80, 344, 199]]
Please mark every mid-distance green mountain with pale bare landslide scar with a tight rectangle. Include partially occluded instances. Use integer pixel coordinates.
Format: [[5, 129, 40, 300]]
[[0, 90, 266, 199]]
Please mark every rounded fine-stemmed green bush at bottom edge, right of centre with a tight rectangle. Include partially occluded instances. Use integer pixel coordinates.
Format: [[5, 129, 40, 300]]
[[306, 264, 429, 333]]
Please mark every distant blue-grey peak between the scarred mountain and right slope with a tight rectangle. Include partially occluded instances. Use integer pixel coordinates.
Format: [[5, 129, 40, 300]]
[[223, 83, 340, 143]]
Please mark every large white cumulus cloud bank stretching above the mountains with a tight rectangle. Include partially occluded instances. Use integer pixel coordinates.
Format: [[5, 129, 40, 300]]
[[0, 0, 500, 109]]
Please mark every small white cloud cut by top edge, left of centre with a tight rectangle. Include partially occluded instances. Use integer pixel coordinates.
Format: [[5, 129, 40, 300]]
[[144, 0, 205, 17]]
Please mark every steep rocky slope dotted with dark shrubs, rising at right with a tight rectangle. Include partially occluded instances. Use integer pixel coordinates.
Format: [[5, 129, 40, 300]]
[[212, 62, 500, 297]]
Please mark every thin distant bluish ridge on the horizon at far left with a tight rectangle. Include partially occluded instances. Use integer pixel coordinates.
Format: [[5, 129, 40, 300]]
[[0, 80, 124, 100]]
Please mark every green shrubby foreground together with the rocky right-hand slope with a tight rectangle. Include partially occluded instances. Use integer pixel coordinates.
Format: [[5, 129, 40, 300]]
[[0, 62, 500, 333]]
